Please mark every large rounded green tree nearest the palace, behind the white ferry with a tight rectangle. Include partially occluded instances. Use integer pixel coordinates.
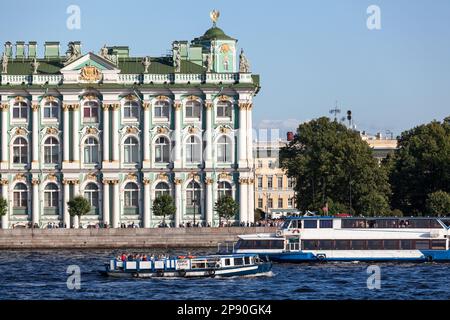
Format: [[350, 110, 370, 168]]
[[280, 117, 390, 214]]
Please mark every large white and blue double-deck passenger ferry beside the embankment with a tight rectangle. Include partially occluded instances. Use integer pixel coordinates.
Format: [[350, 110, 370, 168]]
[[223, 216, 450, 262]]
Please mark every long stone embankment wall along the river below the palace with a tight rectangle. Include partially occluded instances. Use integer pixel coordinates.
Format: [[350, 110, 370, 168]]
[[0, 227, 276, 250]]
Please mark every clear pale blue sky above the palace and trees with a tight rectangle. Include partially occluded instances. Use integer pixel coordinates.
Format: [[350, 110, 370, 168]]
[[0, 0, 450, 134]]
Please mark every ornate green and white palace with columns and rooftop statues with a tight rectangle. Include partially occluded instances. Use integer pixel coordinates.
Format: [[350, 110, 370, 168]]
[[0, 14, 260, 228]]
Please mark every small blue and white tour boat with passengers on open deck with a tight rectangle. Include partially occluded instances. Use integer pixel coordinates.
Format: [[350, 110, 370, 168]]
[[101, 254, 272, 278]]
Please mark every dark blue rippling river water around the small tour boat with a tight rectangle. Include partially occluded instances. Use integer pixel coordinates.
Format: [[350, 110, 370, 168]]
[[0, 249, 450, 300]]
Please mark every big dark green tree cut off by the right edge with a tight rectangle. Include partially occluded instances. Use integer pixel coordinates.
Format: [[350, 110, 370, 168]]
[[390, 118, 450, 215]]
